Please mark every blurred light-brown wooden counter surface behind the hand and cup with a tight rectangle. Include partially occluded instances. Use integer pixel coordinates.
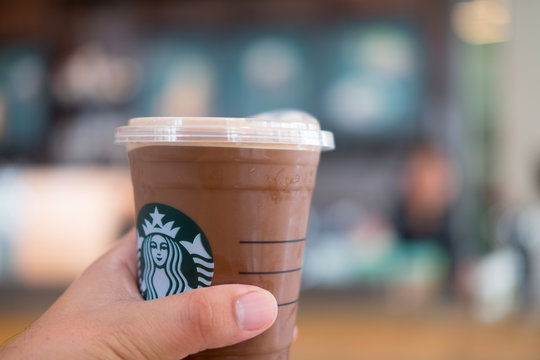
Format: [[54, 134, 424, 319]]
[[0, 297, 540, 360]]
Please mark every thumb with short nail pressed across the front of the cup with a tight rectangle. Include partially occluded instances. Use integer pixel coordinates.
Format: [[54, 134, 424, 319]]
[[122, 285, 277, 359]]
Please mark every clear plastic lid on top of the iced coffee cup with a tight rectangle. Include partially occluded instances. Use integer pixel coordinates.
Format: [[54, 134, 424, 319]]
[[115, 110, 335, 151]]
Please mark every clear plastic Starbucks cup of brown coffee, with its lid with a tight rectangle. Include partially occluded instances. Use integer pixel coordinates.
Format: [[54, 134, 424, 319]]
[[115, 111, 334, 360]]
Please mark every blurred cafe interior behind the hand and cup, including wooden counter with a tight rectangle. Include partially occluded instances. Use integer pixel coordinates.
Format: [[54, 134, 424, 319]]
[[0, 0, 540, 360]]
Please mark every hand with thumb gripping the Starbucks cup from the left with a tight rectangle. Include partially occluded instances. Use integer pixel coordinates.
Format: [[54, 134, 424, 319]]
[[0, 231, 277, 360]]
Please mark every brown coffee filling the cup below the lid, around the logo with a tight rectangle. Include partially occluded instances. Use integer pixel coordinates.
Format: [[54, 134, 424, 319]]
[[129, 145, 319, 360]]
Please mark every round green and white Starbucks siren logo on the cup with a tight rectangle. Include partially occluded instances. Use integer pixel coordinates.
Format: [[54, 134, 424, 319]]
[[137, 203, 214, 300]]
